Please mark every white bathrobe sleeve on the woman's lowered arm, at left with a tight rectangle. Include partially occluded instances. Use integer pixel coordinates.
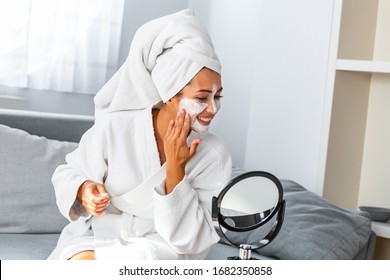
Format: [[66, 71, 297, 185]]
[[52, 119, 107, 221]]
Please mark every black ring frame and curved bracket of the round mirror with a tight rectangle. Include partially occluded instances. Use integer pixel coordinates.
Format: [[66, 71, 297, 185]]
[[211, 171, 286, 249]]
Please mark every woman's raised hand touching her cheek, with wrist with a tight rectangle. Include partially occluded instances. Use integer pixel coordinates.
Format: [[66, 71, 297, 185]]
[[164, 110, 200, 194]]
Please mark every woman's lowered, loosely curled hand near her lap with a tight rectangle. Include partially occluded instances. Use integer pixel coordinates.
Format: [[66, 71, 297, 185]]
[[77, 180, 110, 216]]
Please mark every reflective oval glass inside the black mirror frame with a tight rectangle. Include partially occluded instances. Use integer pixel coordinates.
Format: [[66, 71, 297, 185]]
[[220, 176, 279, 229]]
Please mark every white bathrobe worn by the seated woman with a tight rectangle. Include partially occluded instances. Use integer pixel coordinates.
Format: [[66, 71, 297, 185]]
[[49, 107, 231, 259]]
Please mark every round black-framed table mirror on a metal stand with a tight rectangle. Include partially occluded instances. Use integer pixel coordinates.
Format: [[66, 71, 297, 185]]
[[212, 171, 285, 259]]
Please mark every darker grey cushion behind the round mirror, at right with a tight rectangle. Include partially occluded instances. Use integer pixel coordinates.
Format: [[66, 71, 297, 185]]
[[222, 167, 371, 260]]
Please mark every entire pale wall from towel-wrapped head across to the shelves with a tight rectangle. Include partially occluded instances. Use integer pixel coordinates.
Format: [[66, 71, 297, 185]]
[[189, 0, 333, 194]]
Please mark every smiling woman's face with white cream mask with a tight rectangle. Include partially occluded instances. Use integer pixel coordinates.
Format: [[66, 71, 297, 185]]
[[176, 68, 222, 133]]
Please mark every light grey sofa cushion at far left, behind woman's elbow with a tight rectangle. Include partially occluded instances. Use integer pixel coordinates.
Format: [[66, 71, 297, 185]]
[[0, 125, 78, 233]]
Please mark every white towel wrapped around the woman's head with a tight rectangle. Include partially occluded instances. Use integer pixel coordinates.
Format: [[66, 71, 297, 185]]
[[95, 9, 221, 117]]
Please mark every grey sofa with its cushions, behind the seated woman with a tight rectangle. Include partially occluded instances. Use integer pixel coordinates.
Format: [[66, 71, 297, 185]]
[[0, 109, 375, 260]]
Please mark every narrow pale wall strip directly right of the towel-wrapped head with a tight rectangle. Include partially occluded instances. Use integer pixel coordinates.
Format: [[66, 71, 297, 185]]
[[189, 0, 262, 167]]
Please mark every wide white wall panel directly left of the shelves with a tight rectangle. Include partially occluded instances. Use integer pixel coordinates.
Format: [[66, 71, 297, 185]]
[[245, 0, 333, 194]]
